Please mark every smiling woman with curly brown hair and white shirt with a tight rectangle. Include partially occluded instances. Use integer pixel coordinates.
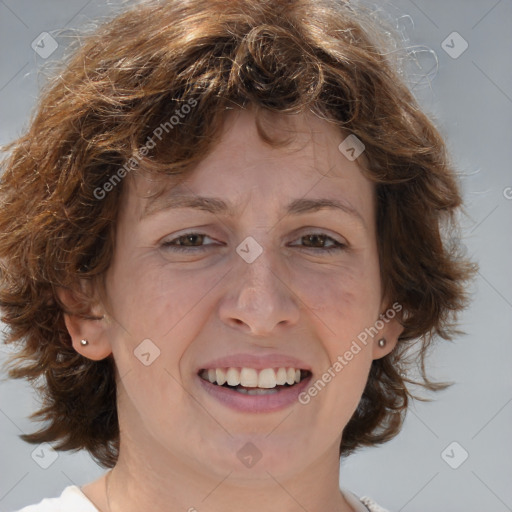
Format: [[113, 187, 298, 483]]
[[0, 0, 473, 512]]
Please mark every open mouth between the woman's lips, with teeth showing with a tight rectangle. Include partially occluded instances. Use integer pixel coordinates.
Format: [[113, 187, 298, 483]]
[[198, 367, 311, 396]]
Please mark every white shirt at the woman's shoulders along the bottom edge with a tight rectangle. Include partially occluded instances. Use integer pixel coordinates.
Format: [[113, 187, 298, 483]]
[[13, 485, 388, 512]]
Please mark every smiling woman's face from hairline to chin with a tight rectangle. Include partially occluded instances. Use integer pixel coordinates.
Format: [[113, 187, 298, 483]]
[[90, 111, 396, 481]]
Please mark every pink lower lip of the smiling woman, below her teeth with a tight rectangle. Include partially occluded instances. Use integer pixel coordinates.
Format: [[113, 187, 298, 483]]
[[197, 375, 312, 412]]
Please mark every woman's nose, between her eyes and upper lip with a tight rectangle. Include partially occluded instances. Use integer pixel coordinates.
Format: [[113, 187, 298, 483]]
[[219, 249, 300, 337]]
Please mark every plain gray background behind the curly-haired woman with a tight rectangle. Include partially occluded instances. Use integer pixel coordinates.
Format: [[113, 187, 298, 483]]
[[0, 0, 512, 512]]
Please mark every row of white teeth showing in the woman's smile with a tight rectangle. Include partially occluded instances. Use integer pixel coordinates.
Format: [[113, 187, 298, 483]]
[[201, 367, 301, 388]]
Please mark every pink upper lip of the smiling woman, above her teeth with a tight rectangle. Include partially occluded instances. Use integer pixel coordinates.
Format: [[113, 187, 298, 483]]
[[197, 354, 311, 372]]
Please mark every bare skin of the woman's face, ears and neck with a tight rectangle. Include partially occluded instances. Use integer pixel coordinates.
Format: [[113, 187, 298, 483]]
[[61, 110, 401, 512]]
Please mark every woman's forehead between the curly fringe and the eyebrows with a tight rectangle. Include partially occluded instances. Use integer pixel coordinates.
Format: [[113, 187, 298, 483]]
[[122, 111, 374, 220]]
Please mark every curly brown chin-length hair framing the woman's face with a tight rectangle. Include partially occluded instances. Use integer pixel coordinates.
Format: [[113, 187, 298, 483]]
[[0, 0, 475, 467]]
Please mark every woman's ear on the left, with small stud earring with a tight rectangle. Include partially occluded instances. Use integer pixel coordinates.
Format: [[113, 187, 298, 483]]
[[57, 288, 112, 361]]
